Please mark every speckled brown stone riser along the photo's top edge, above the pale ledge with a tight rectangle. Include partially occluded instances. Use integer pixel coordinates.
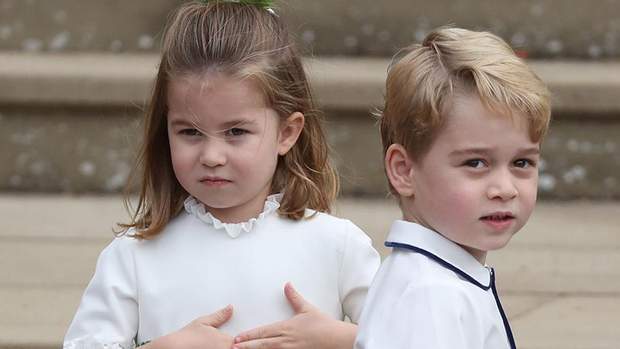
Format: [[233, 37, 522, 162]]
[[0, 0, 620, 59]]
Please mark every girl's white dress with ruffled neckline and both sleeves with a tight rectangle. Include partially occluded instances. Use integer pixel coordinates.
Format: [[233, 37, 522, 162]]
[[64, 195, 380, 349]]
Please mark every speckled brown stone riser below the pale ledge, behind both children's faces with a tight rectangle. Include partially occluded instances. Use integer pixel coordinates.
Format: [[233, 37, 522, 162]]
[[0, 107, 620, 199]]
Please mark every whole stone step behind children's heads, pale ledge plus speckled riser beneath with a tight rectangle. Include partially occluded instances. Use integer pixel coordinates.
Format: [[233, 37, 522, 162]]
[[0, 52, 620, 199]]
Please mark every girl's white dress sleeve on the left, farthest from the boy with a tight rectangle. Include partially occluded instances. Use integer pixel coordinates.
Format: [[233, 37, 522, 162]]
[[63, 237, 138, 349]]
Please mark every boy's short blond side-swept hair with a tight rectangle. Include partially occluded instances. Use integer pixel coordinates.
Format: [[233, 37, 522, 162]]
[[378, 27, 551, 194]]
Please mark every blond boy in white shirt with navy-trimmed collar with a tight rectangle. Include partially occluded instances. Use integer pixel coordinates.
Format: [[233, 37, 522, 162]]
[[355, 28, 550, 349]]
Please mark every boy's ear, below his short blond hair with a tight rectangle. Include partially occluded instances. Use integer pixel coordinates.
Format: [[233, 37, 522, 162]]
[[385, 144, 415, 197]]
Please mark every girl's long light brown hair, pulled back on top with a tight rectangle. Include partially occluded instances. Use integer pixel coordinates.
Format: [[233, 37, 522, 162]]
[[119, 0, 338, 238]]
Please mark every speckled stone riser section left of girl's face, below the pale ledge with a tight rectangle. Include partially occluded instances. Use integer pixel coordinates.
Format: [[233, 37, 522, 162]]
[[0, 107, 141, 192]]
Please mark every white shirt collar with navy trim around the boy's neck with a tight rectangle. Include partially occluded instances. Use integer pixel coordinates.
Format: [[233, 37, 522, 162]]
[[385, 220, 491, 290]]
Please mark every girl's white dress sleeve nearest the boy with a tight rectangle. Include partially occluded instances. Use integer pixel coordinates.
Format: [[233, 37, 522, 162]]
[[339, 221, 381, 323]]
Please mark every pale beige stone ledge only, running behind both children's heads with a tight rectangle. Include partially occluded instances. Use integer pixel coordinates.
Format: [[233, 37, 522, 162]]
[[0, 51, 620, 113]]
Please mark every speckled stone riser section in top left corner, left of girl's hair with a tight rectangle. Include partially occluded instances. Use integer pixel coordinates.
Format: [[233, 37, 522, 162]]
[[0, 0, 182, 52]]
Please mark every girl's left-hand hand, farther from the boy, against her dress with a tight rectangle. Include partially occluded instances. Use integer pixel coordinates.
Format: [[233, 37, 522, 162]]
[[140, 305, 233, 349]]
